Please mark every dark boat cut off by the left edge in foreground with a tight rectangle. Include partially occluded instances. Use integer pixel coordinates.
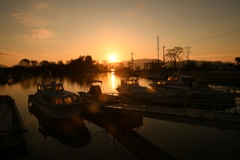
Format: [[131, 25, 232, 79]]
[[0, 95, 29, 159]]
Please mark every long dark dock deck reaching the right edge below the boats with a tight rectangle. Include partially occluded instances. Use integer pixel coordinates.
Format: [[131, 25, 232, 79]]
[[101, 105, 240, 132]]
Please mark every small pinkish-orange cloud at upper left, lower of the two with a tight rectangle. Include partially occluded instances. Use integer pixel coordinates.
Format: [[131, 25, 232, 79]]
[[24, 29, 52, 39]]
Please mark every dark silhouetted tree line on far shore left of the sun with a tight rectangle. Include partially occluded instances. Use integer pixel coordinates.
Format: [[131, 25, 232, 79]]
[[12, 55, 108, 74]]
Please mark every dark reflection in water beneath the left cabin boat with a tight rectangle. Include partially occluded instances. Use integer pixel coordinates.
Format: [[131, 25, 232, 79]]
[[29, 107, 91, 152]]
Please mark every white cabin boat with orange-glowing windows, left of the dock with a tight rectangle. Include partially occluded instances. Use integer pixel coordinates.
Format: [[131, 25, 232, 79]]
[[28, 82, 88, 118]]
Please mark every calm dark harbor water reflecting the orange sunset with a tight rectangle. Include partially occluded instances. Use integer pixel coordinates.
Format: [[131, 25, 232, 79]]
[[0, 73, 240, 160]]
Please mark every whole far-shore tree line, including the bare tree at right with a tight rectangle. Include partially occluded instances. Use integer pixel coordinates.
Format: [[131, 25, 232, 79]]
[[3, 46, 238, 78]]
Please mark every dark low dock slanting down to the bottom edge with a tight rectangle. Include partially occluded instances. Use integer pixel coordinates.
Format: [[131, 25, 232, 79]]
[[82, 104, 174, 160]]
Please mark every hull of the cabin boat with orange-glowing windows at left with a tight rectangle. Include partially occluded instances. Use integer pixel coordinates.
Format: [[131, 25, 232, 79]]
[[28, 95, 88, 119]]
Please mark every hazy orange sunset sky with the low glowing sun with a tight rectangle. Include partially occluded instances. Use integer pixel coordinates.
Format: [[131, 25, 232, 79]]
[[0, 0, 240, 66]]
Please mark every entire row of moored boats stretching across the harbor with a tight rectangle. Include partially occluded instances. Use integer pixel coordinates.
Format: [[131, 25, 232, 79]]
[[28, 74, 236, 118]]
